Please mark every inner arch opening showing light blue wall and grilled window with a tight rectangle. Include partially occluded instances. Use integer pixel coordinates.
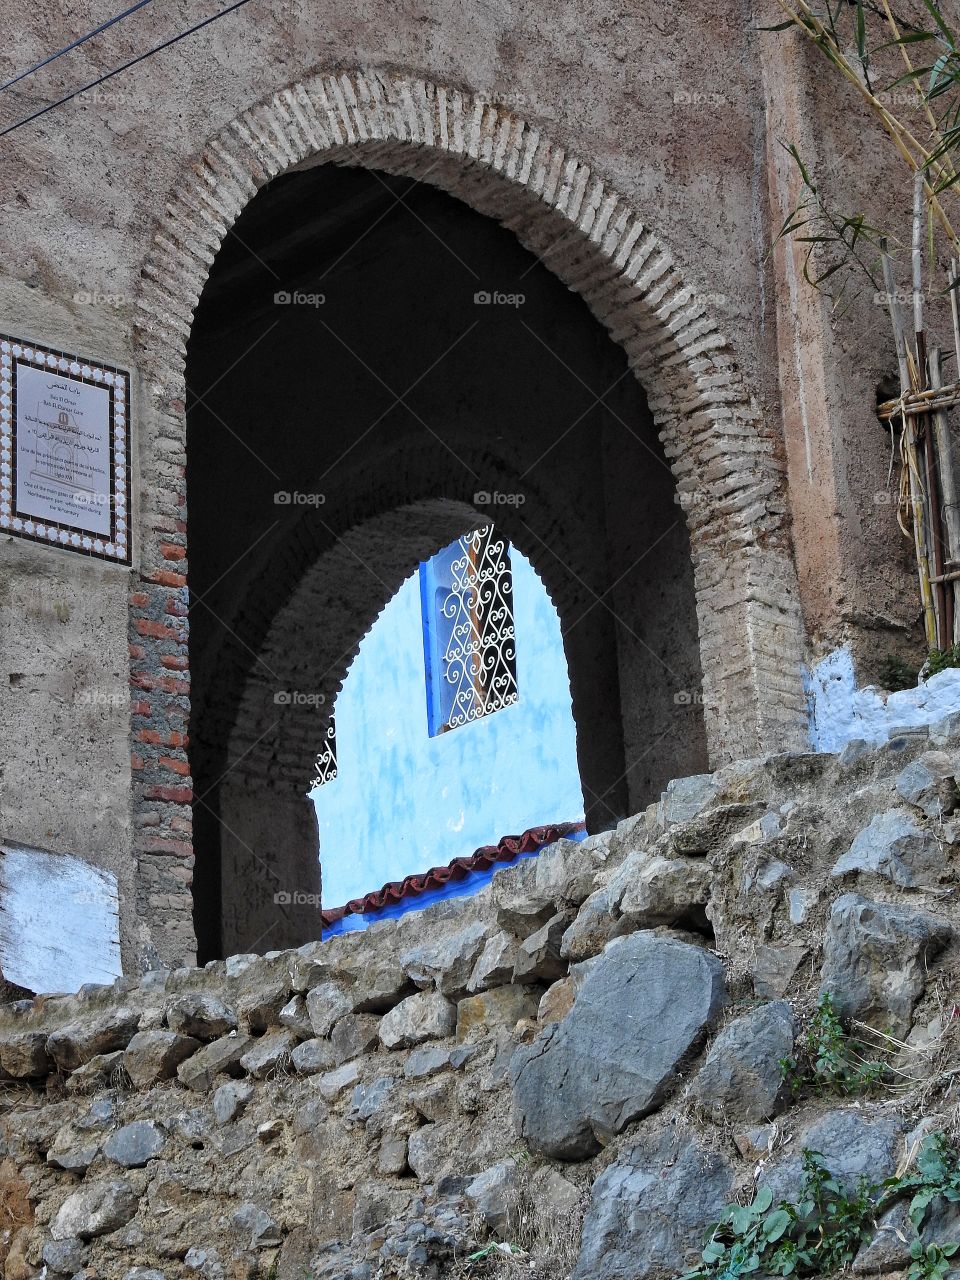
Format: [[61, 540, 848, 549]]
[[311, 535, 584, 918]]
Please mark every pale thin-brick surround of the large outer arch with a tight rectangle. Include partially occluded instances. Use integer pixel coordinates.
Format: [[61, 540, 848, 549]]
[[132, 72, 805, 962]]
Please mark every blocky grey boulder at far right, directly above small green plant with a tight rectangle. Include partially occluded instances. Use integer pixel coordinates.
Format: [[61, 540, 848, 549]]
[[820, 893, 951, 1037]]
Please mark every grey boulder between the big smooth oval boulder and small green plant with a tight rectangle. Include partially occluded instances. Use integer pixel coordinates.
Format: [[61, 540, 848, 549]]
[[690, 1000, 795, 1120]]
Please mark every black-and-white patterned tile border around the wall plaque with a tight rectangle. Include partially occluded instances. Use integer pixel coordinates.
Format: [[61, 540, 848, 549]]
[[0, 334, 132, 564]]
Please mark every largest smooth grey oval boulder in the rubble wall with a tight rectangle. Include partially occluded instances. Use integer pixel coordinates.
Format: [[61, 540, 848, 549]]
[[509, 933, 724, 1160]]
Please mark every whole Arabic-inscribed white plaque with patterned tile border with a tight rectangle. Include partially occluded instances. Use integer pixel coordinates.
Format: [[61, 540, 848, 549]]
[[0, 335, 131, 564]]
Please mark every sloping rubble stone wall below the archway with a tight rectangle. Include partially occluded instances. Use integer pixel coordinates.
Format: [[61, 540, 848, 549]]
[[0, 717, 960, 1280]]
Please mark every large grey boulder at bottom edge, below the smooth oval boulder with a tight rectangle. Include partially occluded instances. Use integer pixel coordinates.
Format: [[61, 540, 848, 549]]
[[572, 1126, 733, 1280]]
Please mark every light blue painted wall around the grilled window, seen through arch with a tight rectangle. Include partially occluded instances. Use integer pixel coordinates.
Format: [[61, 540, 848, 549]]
[[311, 548, 584, 908]]
